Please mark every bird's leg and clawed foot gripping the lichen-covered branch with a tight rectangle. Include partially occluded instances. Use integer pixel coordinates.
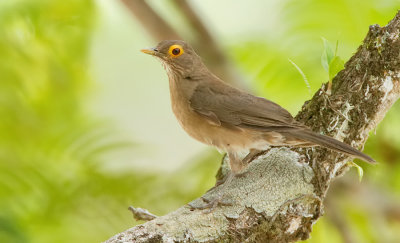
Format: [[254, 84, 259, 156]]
[[189, 152, 245, 212]]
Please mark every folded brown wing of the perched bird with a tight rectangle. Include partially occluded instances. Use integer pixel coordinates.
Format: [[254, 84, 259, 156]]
[[190, 82, 305, 131]]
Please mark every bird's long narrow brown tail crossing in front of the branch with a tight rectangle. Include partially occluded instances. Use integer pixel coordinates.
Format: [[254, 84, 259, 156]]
[[284, 130, 376, 164]]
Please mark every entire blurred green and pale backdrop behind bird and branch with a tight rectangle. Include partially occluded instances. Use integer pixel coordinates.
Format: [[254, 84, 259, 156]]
[[0, 0, 400, 243]]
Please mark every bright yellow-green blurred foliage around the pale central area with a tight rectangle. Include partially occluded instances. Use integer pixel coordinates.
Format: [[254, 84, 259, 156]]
[[0, 0, 400, 242]]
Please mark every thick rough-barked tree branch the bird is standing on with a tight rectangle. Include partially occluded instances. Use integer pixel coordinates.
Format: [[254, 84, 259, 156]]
[[106, 12, 400, 243]]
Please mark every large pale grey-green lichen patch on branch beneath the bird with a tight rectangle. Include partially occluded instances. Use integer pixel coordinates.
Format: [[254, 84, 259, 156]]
[[191, 148, 314, 218]]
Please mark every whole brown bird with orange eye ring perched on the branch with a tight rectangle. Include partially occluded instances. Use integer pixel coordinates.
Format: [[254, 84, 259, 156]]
[[141, 40, 376, 208]]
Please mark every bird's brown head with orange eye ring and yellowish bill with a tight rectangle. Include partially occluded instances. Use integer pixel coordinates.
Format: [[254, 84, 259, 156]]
[[141, 40, 203, 77]]
